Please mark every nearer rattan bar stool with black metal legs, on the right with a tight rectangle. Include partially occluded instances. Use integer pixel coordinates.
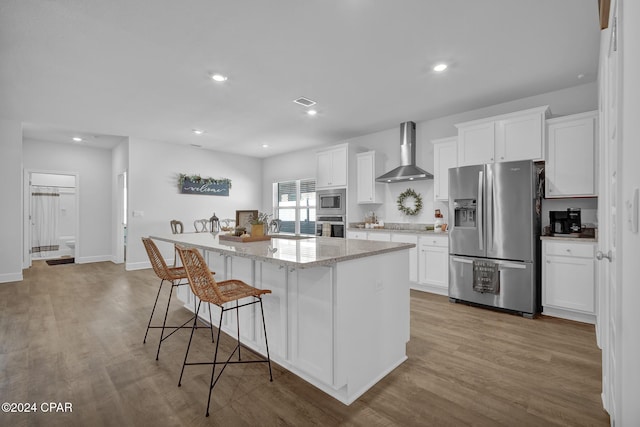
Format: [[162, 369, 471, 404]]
[[176, 245, 273, 417]]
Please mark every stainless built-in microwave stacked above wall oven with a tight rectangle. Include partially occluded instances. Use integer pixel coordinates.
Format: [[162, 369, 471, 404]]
[[316, 188, 347, 237]]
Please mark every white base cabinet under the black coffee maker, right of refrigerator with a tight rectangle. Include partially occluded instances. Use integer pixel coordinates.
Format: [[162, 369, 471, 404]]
[[542, 240, 596, 323]]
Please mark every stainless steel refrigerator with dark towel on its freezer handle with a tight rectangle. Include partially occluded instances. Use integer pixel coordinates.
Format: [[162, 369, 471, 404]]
[[449, 161, 542, 317]]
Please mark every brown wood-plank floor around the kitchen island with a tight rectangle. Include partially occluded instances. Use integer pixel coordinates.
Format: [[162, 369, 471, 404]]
[[0, 262, 609, 426]]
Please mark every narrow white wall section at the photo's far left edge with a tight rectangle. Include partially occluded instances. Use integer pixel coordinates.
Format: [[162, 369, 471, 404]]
[[0, 119, 24, 283]]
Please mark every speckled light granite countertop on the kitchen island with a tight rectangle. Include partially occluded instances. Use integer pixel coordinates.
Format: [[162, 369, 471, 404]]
[[149, 233, 415, 268]]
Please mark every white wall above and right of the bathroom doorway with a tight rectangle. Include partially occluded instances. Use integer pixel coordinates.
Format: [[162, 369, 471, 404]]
[[22, 140, 113, 263]]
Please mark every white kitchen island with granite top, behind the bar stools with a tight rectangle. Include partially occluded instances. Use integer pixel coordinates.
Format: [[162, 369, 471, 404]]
[[150, 233, 415, 405]]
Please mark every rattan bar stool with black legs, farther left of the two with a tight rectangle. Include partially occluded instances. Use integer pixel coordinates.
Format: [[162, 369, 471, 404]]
[[142, 237, 213, 360]]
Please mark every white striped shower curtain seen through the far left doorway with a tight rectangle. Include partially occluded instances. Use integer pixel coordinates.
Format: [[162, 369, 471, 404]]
[[31, 186, 60, 258]]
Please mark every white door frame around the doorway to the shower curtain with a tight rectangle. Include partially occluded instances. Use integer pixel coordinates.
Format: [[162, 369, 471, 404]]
[[22, 169, 80, 268]]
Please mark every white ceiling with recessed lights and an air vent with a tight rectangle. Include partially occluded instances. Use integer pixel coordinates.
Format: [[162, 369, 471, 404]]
[[0, 0, 600, 157]]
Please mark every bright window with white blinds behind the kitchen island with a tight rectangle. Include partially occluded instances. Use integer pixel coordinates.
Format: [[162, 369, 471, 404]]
[[274, 179, 316, 234]]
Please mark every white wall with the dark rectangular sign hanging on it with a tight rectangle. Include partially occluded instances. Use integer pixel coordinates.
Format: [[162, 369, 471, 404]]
[[126, 138, 263, 270]]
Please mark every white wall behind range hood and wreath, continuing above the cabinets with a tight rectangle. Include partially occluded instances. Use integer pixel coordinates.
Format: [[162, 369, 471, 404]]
[[262, 83, 598, 227]]
